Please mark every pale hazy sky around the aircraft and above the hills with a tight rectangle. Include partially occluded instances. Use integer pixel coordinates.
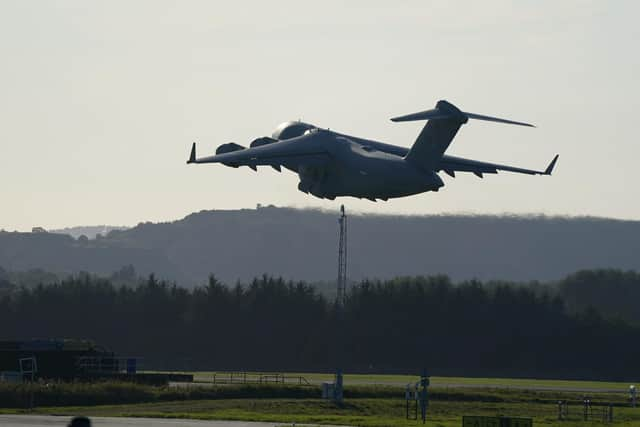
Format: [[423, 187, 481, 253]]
[[0, 0, 640, 230]]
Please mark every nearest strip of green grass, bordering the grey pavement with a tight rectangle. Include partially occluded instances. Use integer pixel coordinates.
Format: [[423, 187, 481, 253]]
[[5, 399, 640, 427]]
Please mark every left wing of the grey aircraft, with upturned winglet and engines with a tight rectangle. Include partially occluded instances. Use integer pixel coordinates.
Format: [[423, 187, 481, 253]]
[[187, 137, 330, 170]]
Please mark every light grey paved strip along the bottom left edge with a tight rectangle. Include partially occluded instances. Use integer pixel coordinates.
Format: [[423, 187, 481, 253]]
[[0, 415, 294, 427]]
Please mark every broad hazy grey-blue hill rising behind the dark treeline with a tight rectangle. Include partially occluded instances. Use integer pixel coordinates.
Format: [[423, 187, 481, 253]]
[[0, 207, 640, 285]]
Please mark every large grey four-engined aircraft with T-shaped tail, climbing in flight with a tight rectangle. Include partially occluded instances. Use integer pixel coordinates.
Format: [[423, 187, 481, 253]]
[[187, 101, 558, 201]]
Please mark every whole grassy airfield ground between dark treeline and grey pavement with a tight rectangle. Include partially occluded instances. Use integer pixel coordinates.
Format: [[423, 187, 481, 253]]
[[0, 372, 640, 427]]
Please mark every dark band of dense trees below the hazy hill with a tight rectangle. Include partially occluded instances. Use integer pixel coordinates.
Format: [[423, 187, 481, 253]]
[[0, 276, 640, 380]]
